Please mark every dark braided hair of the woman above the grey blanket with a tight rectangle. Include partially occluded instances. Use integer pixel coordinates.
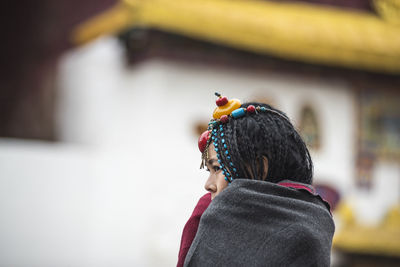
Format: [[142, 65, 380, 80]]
[[217, 102, 313, 184]]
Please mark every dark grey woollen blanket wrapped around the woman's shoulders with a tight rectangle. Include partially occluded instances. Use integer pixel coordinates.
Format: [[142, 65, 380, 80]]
[[184, 179, 334, 266]]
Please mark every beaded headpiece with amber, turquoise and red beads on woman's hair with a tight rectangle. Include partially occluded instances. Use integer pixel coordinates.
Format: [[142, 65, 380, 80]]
[[198, 93, 288, 183]]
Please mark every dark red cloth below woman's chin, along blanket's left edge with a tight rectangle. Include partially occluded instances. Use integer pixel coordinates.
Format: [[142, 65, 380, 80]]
[[176, 193, 211, 267]]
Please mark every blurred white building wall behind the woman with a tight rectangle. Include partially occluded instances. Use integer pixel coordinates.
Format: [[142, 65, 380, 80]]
[[0, 36, 396, 266]]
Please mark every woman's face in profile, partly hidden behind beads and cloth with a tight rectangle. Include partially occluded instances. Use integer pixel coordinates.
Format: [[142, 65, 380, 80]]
[[204, 144, 228, 199]]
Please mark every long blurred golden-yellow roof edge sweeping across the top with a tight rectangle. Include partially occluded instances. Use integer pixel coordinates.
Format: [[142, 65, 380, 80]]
[[73, 0, 400, 74]]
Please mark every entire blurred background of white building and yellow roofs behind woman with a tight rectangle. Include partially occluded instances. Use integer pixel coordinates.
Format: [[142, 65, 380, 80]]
[[0, 0, 400, 266]]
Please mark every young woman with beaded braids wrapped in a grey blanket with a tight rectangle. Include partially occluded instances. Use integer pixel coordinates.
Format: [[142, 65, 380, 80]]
[[178, 93, 334, 266]]
